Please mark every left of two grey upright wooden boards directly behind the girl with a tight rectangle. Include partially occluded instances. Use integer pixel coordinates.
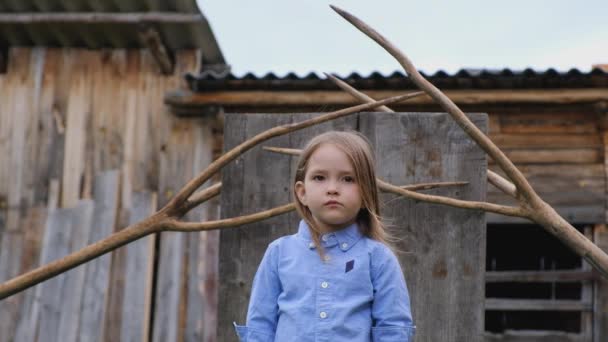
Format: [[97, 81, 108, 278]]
[[217, 114, 357, 341]]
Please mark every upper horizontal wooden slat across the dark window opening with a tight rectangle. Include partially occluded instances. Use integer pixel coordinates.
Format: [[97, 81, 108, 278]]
[[486, 270, 597, 283]]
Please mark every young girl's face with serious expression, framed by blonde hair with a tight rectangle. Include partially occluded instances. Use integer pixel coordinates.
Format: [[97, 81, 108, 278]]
[[295, 144, 362, 232]]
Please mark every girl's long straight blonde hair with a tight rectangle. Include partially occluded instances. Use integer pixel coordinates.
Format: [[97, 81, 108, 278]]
[[292, 131, 396, 259]]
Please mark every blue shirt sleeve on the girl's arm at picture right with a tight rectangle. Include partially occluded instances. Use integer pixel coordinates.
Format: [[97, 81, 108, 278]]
[[371, 247, 416, 342]]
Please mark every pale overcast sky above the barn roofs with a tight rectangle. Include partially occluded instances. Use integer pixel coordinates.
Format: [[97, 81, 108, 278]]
[[197, 0, 608, 76]]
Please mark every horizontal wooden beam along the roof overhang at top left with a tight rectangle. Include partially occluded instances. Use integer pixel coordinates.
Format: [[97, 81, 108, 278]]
[[0, 12, 205, 24]]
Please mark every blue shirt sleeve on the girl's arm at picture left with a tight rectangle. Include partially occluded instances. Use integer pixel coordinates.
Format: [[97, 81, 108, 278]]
[[233, 240, 281, 342]]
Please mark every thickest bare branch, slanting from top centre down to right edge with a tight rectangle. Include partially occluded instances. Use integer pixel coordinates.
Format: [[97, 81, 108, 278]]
[[331, 6, 608, 278]]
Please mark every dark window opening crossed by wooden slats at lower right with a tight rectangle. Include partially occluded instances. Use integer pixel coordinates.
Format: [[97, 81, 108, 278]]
[[485, 224, 585, 333]]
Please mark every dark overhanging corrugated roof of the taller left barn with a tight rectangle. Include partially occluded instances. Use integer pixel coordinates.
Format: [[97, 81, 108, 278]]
[[0, 0, 225, 64]]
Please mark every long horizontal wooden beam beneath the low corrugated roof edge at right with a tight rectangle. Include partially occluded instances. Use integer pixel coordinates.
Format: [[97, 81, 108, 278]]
[[165, 88, 608, 106]]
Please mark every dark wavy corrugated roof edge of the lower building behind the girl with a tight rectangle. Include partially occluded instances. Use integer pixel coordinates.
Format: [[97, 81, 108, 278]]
[[186, 68, 608, 91]]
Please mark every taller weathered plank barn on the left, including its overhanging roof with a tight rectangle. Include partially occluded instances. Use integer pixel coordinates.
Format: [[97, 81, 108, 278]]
[[0, 0, 226, 341]]
